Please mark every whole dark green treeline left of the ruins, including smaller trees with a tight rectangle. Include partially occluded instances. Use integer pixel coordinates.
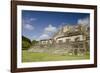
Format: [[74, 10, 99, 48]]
[[22, 36, 38, 50]]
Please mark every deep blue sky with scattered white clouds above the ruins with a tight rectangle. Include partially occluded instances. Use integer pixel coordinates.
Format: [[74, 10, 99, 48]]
[[22, 10, 90, 40]]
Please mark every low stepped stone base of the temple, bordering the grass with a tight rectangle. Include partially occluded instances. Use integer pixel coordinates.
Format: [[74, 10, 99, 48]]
[[28, 42, 86, 55]]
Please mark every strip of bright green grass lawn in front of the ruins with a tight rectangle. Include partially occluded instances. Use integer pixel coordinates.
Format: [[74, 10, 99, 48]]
[[22, 50, 90, 62]]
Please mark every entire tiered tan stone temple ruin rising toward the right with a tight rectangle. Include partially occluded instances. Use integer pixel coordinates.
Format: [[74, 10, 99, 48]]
[[29, 24, 90, 55]]
